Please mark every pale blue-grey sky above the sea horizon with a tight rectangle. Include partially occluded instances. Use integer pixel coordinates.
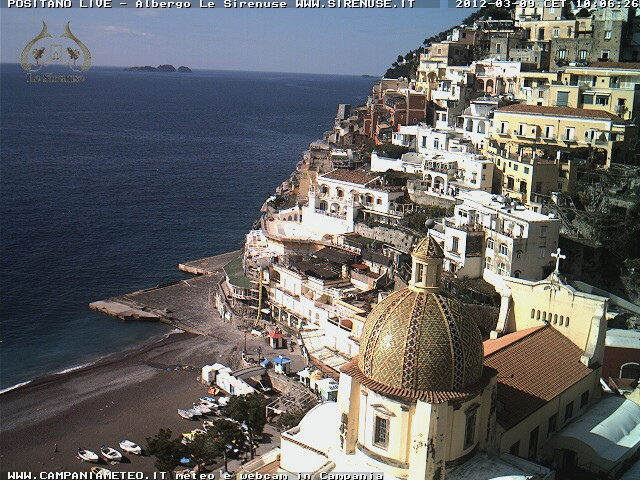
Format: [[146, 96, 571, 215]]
[[0, 0, 472, 76]]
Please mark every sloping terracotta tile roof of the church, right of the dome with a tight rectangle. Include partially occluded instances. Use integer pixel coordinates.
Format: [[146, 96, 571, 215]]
[[484, 325, 592, 429]]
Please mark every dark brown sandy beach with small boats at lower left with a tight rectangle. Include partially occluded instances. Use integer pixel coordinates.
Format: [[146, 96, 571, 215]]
[[0, 324, 301, 472]]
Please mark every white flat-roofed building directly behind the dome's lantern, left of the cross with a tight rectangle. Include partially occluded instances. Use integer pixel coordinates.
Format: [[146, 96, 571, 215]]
[[430, 191, 560, 280]]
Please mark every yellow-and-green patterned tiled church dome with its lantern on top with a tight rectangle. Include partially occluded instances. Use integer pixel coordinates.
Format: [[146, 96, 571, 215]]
[[354, 238, 484, 398]]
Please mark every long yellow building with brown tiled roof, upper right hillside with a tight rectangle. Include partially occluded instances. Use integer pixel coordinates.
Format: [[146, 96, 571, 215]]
[[486, 104, 637, 203]]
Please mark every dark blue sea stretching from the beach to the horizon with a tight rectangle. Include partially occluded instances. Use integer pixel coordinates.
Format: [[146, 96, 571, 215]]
[[0, 64, 373, 389]]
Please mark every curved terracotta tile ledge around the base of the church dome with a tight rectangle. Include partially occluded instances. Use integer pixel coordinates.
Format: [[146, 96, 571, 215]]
[[340, 356, 496, 403]]
